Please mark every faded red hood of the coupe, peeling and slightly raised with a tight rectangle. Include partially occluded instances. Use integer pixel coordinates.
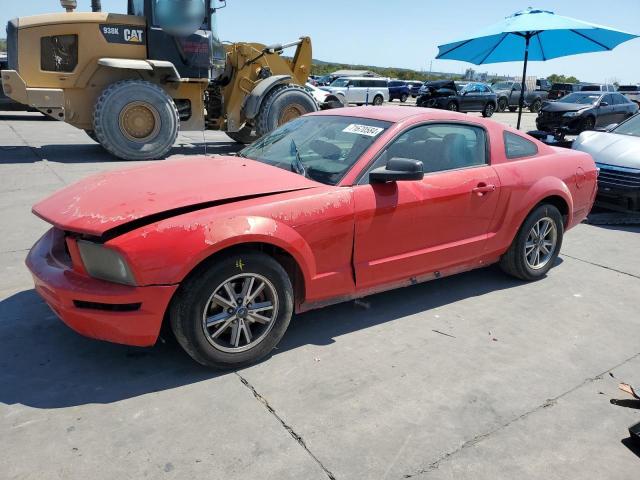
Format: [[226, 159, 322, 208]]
[[33, 156, 321, 236]]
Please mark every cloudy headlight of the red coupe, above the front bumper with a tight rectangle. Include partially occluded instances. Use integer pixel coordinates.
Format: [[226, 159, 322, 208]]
[[77, 240, 135, 285]]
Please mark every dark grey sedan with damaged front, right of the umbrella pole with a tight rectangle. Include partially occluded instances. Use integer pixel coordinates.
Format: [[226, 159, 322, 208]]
[[536, 92, 638, 135]]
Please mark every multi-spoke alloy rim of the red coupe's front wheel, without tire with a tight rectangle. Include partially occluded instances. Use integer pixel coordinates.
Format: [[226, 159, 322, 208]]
[[202, 273, 278, 353]]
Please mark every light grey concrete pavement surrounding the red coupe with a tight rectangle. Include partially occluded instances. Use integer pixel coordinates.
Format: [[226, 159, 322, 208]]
[[0, 112, 640, 480]]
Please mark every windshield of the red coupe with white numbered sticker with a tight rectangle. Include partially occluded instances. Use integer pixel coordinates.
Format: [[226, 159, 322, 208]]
[[239, 115, 391, 185]]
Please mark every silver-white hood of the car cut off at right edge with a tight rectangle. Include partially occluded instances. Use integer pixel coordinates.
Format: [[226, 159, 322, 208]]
[[573, 131, 640, 169]]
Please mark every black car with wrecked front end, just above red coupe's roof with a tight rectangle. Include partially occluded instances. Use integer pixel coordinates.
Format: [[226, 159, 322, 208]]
[[416, 80, 497, 117]]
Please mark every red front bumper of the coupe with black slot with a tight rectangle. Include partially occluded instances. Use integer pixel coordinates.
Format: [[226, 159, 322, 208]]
[[26, 228, 178, 347]]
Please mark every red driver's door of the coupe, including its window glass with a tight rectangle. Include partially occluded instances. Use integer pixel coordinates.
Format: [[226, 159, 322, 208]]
[[354, 123, 500, 291]]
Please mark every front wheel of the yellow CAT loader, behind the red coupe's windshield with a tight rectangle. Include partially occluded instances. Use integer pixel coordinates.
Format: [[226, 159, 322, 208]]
[[255, 84, 318, 137]]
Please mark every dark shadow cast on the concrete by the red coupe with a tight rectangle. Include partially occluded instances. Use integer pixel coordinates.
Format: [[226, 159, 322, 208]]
[[0, 267, 522, 408]]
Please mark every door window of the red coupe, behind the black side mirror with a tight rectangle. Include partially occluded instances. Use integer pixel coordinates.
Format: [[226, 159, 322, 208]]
[[360, 123, 488, 183]]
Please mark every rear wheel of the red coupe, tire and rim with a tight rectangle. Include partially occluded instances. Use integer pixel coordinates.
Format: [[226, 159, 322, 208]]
[[500, 204, 564, 281]]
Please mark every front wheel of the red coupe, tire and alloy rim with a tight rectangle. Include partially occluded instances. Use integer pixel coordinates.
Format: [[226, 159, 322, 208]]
[[169, 252, 293, 368]]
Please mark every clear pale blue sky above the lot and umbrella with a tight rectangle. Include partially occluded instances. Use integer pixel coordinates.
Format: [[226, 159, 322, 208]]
[[0, 0, 640, 83]]
